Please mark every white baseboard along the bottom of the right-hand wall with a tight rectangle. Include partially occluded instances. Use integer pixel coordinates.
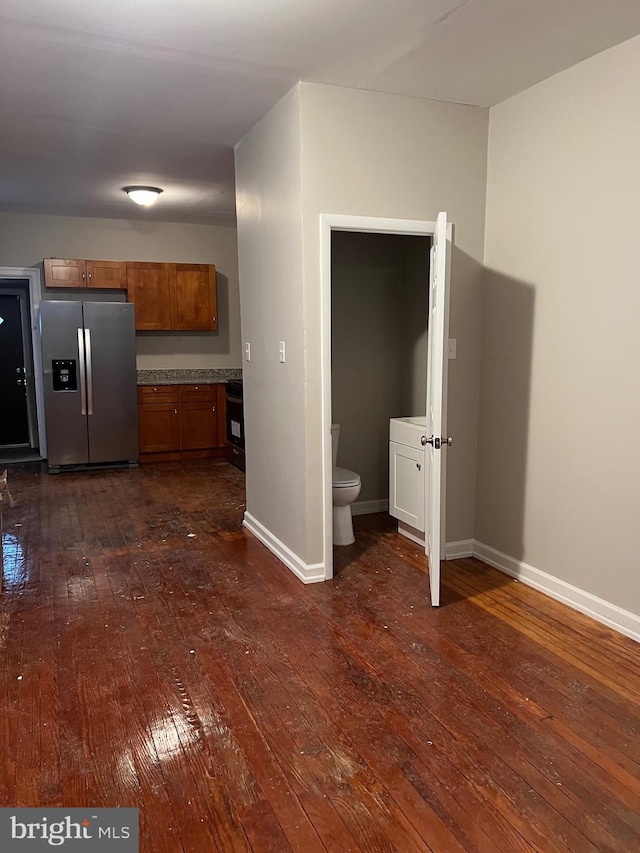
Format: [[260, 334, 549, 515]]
[[473, 540, 640, 642]]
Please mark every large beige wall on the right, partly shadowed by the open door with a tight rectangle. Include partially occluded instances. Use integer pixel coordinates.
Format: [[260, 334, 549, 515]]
[[476, 38, 640, 614]]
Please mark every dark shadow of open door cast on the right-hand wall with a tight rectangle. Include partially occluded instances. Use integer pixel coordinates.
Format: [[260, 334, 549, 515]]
[[475, 269, 535, 559]]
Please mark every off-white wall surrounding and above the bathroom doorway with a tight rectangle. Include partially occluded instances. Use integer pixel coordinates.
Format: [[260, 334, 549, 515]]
[[300, 83, 488, 560]]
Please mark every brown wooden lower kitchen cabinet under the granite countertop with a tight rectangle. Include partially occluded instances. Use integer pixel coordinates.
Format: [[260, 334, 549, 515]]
[[138, 384, 227, 462]]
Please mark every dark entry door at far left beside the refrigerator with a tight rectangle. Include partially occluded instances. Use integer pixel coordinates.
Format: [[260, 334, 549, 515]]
[[0, 296, 29, 447]]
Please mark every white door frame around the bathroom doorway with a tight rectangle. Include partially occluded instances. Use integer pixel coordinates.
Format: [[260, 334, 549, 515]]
[[320, 213, 453, 580]]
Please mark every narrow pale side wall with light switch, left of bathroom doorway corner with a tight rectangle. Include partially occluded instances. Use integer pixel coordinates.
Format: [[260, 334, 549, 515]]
[[236, 89, 307, 557]]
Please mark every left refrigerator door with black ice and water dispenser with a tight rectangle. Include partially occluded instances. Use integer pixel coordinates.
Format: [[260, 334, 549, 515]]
[[40, 301, 89, 466]]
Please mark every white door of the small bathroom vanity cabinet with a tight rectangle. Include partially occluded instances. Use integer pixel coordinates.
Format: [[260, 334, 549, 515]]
[[389, 441, 425, 530]]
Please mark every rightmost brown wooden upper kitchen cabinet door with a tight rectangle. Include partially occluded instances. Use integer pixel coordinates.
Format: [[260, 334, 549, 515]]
[[167, 264, 218, 331]]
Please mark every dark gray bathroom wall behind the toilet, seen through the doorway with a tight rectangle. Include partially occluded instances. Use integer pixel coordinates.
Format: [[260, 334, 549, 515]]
[[331, 231, 430, 502]]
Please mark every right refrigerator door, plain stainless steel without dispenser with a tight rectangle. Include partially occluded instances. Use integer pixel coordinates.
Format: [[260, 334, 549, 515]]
[[82, 302, 138, 464]]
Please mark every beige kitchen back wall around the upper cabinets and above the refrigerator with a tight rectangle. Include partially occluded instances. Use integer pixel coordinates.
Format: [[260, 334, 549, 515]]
[[0, 213, 242, 369]]
